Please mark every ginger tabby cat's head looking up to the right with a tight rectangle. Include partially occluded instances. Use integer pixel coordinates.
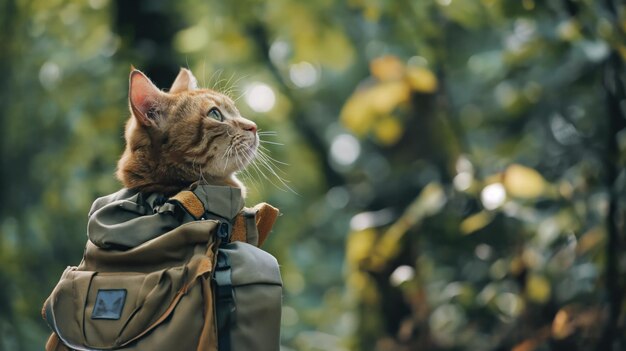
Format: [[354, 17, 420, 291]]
[[117, 68, 259, 196]]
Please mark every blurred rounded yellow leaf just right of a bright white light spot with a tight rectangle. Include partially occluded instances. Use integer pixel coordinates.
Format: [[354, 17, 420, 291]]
[[503, 164, 547, 199]]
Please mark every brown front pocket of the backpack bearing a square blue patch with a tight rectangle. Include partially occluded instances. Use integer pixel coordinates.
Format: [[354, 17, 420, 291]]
[[44, 226, 214, 350]]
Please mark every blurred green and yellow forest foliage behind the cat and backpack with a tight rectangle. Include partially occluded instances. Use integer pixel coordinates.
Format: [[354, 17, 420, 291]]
[[0, 0, 626, 351]]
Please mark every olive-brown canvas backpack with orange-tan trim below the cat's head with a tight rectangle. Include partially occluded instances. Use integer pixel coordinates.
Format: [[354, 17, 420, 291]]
[[42, 183, 282, 351]]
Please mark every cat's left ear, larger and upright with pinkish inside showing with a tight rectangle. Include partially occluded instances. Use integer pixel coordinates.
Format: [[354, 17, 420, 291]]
[[128, 68, 163, 126]]
